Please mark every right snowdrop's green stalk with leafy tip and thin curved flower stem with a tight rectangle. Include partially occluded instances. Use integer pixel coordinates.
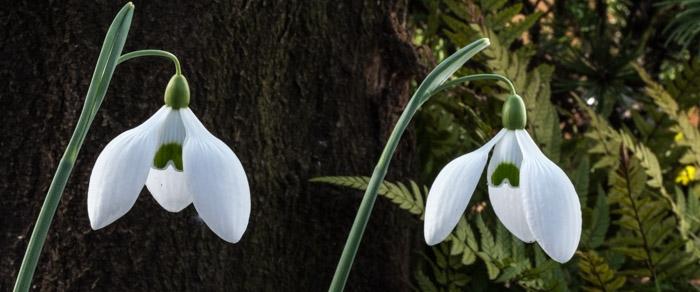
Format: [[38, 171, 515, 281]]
[[328, 39, 515, 292]]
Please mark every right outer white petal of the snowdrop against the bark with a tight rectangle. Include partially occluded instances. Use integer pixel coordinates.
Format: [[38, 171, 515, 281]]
[[180, 108, 250, 243]]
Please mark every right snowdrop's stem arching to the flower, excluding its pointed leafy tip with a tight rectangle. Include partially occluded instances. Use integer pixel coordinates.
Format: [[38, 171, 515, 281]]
[[329, 74, 515, 292]]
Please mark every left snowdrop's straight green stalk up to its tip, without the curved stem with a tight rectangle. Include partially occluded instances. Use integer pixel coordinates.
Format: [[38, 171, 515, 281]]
[[13, 2, 134, 292]]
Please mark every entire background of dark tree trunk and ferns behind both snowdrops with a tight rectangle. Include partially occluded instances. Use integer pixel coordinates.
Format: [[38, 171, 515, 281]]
[[0, 0, 700, 291]]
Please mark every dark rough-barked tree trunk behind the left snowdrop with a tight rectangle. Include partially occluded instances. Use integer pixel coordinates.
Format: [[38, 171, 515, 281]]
[[0, 0, 421, 291]]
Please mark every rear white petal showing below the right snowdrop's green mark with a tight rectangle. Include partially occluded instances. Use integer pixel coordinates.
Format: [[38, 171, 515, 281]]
[[489, 183, 535, 242]]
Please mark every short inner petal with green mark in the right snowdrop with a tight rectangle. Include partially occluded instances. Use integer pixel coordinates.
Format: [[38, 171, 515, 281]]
[[486, 131, 523, 187]]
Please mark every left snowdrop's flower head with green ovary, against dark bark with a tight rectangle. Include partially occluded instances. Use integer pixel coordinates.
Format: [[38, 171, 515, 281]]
[[88, 74, 250, 243]]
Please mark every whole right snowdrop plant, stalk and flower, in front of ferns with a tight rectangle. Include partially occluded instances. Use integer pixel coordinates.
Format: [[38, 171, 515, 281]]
[[330, 39, 581, 291]]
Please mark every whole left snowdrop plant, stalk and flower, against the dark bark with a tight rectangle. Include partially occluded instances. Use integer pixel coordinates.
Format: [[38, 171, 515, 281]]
[[14, 2, 250, 292]]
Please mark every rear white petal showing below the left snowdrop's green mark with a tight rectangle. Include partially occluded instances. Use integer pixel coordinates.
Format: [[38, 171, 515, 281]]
[[146, 162, 192, 212]]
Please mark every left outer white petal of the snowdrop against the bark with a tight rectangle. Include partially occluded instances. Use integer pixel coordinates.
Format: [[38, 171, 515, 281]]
[[87, 107, 170, 229]]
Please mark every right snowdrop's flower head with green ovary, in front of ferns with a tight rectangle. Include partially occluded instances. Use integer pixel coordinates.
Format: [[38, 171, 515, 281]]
[[424, 96, 581, 263]]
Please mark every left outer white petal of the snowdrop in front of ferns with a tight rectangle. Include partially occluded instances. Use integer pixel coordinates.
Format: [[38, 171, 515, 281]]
[[423, 130, 505, 245]]
